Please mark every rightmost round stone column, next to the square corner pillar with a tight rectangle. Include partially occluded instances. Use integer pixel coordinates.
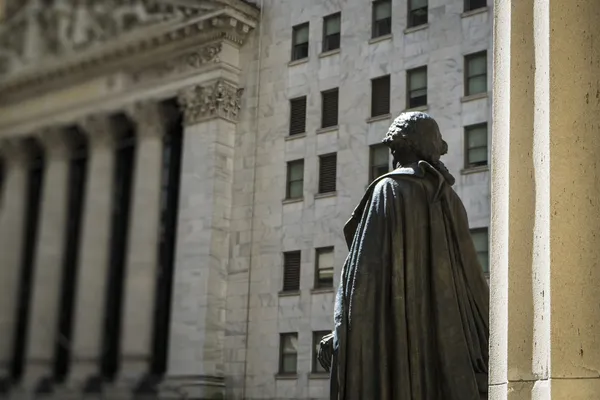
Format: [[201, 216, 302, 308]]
[[113, 102, 166, 388]]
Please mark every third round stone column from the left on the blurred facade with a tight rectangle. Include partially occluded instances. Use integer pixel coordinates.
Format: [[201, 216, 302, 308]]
[[67, 115, 115, 391]]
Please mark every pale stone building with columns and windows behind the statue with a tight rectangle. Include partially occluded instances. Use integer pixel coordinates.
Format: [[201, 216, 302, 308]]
[[0, 0, 492, 399]]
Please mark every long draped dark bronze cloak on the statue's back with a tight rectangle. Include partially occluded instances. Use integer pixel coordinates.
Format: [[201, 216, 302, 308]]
[[331, 161, 489, 400]]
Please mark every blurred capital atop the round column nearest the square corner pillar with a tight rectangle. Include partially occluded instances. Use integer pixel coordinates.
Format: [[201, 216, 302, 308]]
[[125, 100, 169, 138]]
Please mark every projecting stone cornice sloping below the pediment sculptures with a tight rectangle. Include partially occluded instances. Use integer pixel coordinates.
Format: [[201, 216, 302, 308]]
[[0, 0, 258, 101]]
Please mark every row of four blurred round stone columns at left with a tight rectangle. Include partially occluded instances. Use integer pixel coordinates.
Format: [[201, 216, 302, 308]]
[[0, 102, 173, 396]]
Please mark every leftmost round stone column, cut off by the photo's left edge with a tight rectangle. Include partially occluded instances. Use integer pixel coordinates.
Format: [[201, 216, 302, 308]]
[[0, 139, 29, 394]]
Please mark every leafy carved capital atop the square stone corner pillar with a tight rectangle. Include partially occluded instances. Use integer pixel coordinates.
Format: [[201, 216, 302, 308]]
[[178, 79, 244, 125]]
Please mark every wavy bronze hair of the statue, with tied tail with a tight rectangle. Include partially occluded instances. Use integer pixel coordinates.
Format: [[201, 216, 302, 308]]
[[382, 111, 455, 185]]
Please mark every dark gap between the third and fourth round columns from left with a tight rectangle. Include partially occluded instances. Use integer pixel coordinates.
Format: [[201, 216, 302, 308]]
[[101, 115, 135, 382]]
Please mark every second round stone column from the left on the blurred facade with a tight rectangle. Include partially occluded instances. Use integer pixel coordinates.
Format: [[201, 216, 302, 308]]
[[23, 128, 70, 390]]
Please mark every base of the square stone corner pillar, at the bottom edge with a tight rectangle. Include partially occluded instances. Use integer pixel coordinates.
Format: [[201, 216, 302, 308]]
[[159, 375, 225, 400]]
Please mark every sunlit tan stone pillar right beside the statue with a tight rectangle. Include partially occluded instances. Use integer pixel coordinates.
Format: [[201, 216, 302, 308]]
[[490, 0, 600, 400]]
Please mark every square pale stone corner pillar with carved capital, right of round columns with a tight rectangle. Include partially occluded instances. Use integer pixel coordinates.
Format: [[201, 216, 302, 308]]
[[162, 80, 242, 399]]
